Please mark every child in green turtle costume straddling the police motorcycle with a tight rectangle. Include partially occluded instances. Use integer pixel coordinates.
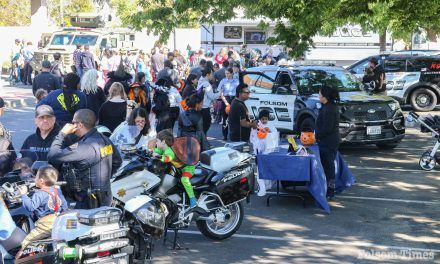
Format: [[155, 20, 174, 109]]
[[153, 130, 197, 208]]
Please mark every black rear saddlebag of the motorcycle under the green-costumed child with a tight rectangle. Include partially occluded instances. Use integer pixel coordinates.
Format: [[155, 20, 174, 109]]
[[214, 164, 255, 205]]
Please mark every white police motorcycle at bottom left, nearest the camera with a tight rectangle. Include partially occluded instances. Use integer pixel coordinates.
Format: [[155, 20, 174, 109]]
[[0, 179, 133, 264]]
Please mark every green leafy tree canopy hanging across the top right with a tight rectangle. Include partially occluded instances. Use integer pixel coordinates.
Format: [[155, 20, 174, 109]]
[[112, 0, 440, 56]]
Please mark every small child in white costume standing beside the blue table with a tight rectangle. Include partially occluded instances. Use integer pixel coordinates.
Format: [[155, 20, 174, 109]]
[[250, 110, 279, 196]]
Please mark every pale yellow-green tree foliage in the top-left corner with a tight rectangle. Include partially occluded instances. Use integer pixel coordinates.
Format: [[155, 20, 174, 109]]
[[0, 0, 31, 27]]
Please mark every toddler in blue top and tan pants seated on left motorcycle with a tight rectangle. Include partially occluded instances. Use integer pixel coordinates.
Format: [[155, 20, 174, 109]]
[[20, 166, 67, 249]]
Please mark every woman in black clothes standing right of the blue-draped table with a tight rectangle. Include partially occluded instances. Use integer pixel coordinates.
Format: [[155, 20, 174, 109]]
[[316, 86, 341, 198]]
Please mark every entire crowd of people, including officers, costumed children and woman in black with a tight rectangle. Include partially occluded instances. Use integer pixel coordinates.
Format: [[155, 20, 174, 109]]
[[0, 41, 348, 250]]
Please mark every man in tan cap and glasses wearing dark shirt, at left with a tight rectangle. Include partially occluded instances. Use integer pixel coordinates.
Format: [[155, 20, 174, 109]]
[[20, 105, 68, 161]]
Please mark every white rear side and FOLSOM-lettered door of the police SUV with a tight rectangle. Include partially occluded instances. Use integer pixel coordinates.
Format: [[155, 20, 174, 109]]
[[240, 71, 296, 131]]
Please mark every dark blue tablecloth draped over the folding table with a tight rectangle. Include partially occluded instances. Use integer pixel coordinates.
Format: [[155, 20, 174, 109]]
[[257, 145, 356, 213]]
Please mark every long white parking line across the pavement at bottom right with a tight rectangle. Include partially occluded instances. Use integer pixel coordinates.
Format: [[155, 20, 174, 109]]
[[179, 230, 440, 253]]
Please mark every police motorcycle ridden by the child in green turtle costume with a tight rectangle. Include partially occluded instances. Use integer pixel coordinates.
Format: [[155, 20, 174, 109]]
[[107, 124, 255, 246]]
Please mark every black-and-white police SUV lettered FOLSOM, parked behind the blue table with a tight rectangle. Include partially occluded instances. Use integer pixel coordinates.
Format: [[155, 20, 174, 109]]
[[240, 62, 405, 148]]
